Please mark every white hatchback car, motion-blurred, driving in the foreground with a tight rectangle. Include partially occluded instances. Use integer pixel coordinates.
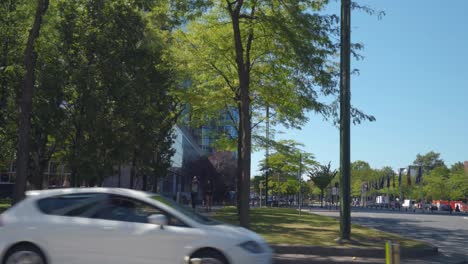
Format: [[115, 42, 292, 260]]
[[0, 188, 272, 264]]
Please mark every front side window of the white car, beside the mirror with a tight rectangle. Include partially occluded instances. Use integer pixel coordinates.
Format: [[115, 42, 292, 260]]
[[93, 195, 186, 226]]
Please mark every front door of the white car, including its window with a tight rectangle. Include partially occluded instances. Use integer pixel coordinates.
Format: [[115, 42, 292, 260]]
[[93, 195, 201, 264]]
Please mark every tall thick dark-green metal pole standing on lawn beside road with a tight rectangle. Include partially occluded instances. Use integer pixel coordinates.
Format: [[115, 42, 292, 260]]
[[340, 0, 351, 240]]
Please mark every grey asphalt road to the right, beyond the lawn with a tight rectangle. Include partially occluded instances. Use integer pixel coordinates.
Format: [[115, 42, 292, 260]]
[[311, 209, 468, 261]]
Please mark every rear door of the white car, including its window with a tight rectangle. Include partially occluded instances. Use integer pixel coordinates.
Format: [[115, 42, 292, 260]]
[[37, 193, 106, 264]]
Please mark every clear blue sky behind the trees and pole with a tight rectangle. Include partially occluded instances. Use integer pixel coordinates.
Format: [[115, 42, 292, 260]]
[[252, 0, 468, 175]]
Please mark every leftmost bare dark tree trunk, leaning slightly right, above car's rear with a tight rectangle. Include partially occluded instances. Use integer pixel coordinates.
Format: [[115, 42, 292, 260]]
[[13, 0, 49, 204]]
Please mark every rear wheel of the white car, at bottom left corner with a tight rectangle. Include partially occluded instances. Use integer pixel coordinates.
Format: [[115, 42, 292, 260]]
[[4, 245, 46, 264]]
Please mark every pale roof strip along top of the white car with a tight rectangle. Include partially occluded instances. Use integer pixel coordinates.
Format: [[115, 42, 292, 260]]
[[26, 187, 152, 198]]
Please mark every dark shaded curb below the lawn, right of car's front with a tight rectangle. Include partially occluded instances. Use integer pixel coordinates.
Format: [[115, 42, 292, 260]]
[[271, 244, 439, 258]]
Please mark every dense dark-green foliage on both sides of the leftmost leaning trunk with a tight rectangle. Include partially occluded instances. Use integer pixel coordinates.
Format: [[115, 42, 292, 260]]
[[0, 0, 180, 188]]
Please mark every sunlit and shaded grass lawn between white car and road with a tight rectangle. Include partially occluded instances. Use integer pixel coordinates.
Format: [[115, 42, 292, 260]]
[[213, 207, 428, 248]]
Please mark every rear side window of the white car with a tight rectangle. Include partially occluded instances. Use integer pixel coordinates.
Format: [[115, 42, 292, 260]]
[[37, 193, 105, 217]]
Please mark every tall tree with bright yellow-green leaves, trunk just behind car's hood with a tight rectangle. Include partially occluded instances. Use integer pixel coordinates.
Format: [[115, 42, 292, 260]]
[[175, 0, 373, 226]]
